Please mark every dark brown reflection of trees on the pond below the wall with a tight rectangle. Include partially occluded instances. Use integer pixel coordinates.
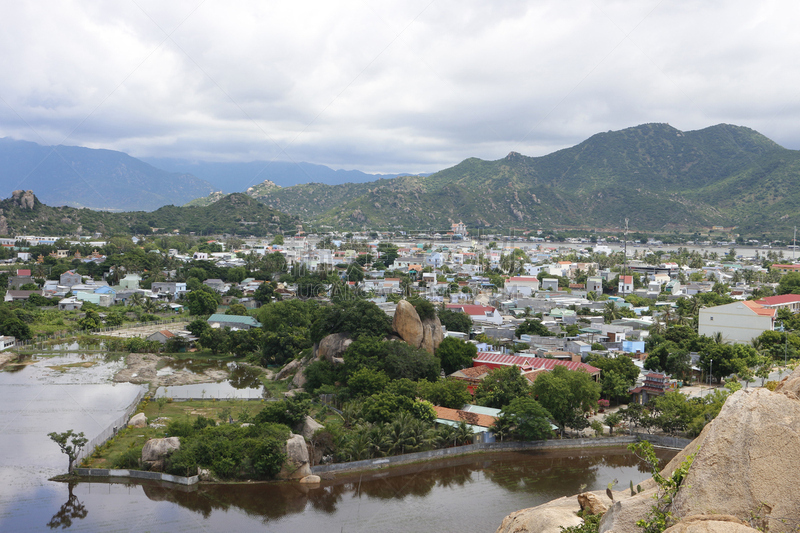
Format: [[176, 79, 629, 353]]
[[114, 448, 675, 522]]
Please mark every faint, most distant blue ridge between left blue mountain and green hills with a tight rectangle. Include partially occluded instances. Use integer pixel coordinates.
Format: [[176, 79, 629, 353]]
[[145, 158, 428, 192]]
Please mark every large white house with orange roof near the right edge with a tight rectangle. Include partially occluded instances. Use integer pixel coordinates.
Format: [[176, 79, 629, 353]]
[[698, 301, 777, 343]]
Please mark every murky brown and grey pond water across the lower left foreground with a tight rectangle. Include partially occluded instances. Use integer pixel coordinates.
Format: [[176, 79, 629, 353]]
[[0, 355, 674, 533]]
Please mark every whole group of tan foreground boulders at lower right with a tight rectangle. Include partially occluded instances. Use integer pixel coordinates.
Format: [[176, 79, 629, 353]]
[[490, 369, 800, 533]]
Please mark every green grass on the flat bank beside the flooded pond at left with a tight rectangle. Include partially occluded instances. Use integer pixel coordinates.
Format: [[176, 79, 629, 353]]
[[81, 400, 272, 468]]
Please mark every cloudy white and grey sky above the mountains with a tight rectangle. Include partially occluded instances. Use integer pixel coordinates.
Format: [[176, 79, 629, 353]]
[[0, 0, 800, 173]]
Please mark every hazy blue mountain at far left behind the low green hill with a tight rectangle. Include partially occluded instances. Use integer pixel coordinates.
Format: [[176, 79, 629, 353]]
[[0, 138, 214, 211]]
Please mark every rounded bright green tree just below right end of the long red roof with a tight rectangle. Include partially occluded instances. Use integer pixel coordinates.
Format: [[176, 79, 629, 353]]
[[533, 365, 600, 436]]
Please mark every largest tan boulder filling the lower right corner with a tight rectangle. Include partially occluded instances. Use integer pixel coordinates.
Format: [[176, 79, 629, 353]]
[[672, 386, 800, 532]]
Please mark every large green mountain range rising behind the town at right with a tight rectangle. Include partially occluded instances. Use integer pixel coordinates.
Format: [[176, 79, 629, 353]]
[[248, 124, 800, 232]]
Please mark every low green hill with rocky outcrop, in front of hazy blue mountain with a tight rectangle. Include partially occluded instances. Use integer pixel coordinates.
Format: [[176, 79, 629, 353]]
[[0, 190, 299, 237]]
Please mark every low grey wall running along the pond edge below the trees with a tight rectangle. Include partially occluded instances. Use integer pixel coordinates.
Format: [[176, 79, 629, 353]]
[[311, 434, 691, 475]]
